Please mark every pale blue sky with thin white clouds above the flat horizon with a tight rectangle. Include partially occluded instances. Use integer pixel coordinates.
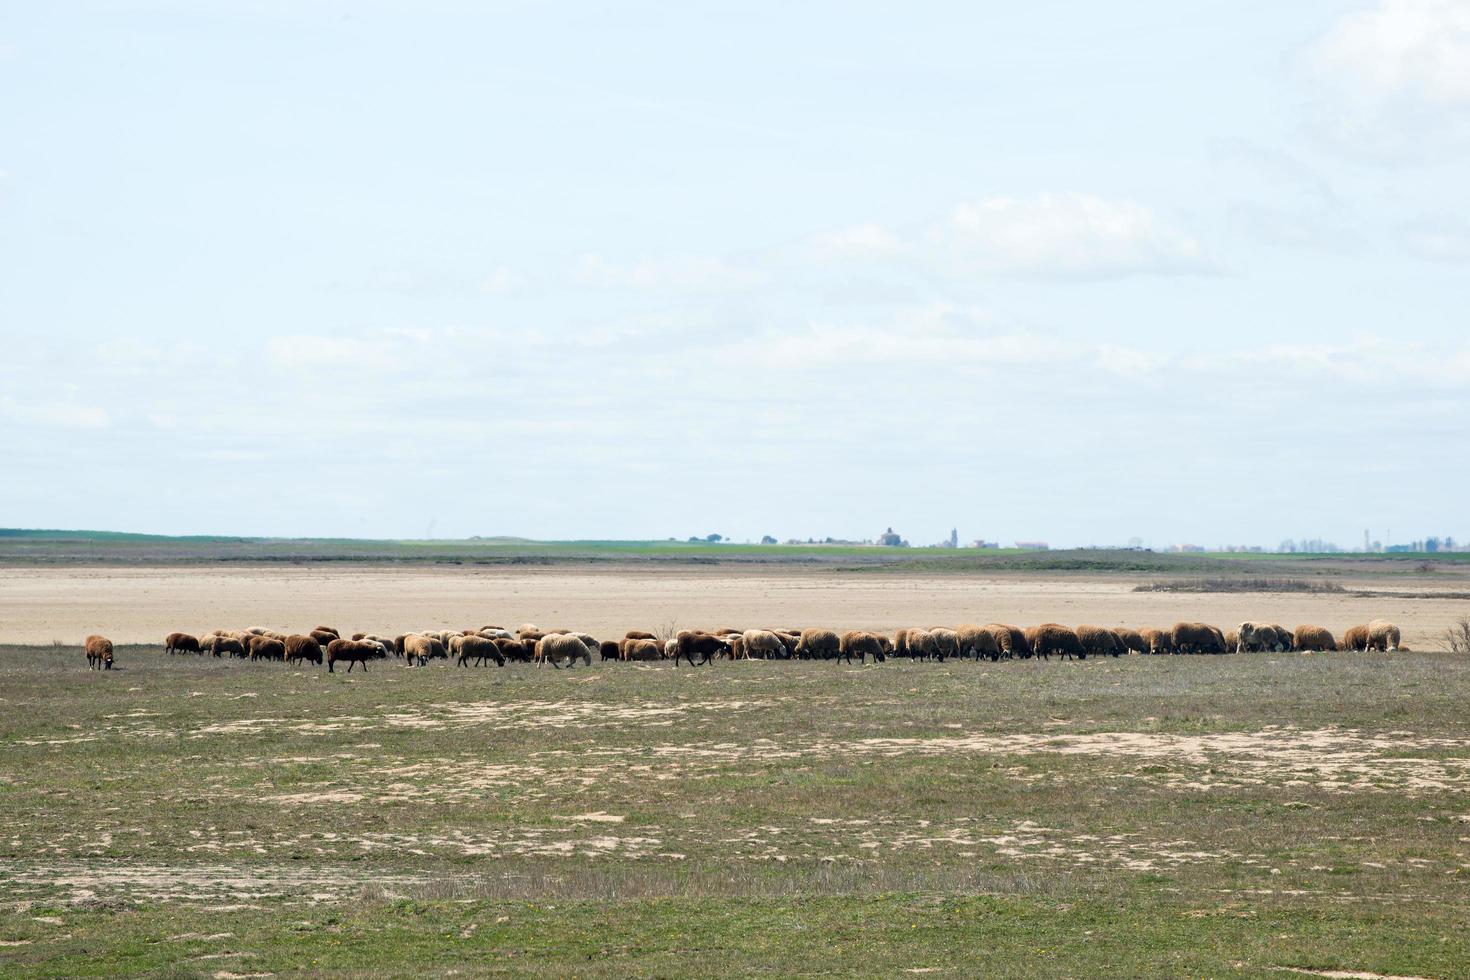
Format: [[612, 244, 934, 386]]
[[0, 0, 1470, 547]]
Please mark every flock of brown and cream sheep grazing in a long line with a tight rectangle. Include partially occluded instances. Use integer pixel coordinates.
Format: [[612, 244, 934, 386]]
[[77, 620, 1407, 673]]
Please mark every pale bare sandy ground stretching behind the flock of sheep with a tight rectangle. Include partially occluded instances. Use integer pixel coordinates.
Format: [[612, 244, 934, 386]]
[[0, 564, 1470, 649]]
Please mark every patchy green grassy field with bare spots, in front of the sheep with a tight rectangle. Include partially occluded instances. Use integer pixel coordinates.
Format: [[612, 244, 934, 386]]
[[0, 646, 1470, 977]]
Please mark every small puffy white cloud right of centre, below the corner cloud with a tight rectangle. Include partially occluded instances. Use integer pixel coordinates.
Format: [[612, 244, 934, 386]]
[[929, 194, 1210, 278]]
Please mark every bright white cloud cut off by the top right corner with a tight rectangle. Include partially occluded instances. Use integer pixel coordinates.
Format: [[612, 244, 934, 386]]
[[1308, 0, 1470, 104]]
